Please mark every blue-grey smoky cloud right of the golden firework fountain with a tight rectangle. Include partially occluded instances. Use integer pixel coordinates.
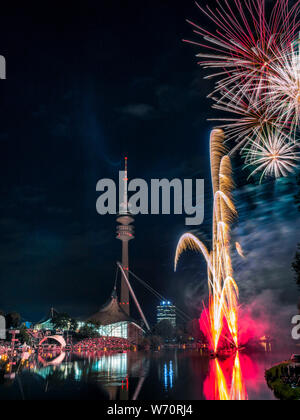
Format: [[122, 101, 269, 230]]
[[233, 179, 300, 307]]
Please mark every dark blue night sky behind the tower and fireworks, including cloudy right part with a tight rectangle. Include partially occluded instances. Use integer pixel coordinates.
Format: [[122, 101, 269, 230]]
[[0, 0, 300, 328]]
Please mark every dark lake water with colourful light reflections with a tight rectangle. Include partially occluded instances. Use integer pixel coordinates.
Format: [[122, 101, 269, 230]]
[[0, 350, 288, 400]]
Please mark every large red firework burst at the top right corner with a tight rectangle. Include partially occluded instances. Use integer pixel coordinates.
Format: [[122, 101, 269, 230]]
[[184, 0, 300, 96]]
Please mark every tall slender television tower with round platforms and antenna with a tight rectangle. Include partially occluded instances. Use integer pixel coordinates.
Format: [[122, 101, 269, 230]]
[[117, 157, 134, 315]]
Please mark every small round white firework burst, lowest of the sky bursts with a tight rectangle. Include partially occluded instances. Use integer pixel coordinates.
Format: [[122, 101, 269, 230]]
[[244, 130, 300, 180]]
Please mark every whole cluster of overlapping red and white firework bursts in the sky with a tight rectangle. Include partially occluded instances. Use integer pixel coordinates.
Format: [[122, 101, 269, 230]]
[[184, 0, 300, 178]]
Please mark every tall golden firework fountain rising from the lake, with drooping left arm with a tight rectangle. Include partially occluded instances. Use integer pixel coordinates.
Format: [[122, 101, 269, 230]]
[[175, 130, 238, 351]]
